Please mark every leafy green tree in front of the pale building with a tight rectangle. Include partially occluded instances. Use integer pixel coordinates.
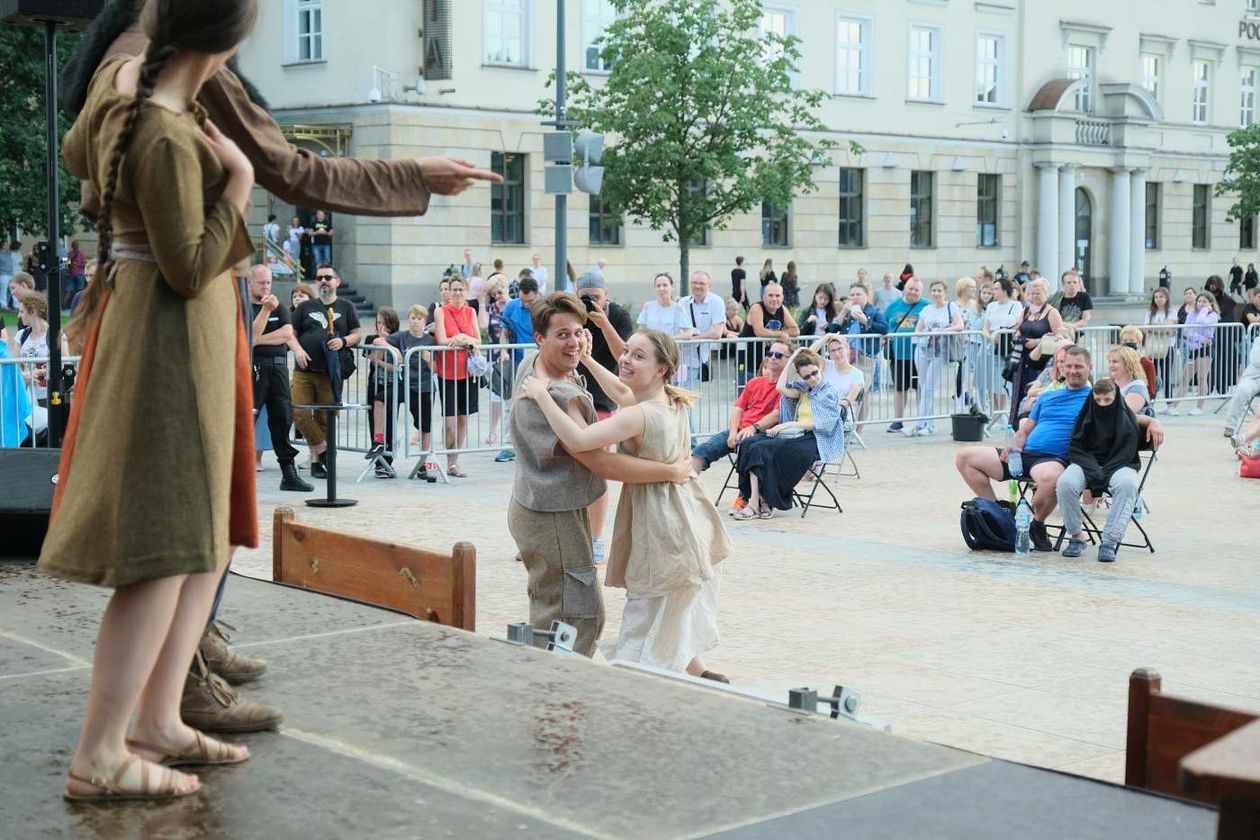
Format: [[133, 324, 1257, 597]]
[[539, 0, 857, 288]]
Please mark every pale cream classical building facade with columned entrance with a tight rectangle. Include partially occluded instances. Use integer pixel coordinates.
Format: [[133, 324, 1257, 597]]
[[241, 0, 1260, 305]]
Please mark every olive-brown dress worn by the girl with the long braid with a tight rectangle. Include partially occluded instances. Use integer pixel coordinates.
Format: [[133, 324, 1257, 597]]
[[39, 55, 257, 587]]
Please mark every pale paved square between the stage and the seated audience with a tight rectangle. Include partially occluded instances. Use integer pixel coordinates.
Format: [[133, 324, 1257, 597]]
[[236, 414, 1260, 781]]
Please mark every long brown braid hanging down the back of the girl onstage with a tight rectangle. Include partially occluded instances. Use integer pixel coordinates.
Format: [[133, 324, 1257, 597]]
[[66, 42, 179, 346]]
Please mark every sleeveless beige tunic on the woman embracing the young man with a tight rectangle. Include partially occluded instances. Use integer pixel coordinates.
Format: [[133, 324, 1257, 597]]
[[605, 402, 731, 598]]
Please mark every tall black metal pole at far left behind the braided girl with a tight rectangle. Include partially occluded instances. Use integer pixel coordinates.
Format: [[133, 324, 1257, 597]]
[[44, 20, 63, 447]]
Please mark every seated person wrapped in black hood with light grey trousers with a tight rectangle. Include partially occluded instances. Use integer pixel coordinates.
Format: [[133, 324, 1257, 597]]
[[1055, 379, 1142, 563]]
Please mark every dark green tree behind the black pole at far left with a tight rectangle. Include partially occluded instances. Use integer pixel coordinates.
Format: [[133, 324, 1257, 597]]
[[0, 25, 79, 238]]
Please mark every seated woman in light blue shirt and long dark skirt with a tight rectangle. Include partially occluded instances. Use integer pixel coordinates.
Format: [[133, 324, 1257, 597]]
[[735, 349, 844, 519]]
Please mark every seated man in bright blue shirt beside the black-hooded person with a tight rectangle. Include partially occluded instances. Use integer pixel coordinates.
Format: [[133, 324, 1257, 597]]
[[954, 345, 1164, 552]]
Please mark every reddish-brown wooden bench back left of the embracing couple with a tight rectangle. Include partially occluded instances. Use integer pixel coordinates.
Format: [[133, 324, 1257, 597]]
[[271, 506, 476, 631]]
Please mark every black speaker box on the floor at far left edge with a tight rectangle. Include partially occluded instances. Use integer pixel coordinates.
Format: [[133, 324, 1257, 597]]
[[0, 450, 62, 559]]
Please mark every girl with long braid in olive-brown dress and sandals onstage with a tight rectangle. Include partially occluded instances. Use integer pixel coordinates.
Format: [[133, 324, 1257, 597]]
[[39, 0, 257, 801]]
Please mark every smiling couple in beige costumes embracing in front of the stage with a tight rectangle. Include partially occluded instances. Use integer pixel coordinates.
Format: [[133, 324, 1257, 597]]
[[508, 292, 731, 681]]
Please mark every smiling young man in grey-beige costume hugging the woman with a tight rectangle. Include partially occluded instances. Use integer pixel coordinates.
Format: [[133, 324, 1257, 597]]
[[508, 292, 693, 656]]
